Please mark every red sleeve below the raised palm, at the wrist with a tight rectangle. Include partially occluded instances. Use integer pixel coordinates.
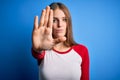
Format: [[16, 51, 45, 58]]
[[31, 48, 45, 64]]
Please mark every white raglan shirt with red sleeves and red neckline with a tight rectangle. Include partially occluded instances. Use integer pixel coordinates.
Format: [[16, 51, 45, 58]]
[[31, 45, 89, 80]]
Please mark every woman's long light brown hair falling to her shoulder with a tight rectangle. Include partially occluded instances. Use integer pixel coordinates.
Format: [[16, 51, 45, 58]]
[[49, 2, 77, 47]]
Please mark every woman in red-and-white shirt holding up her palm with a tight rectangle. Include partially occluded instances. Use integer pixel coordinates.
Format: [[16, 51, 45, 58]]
[[32, 3, 89, 80]]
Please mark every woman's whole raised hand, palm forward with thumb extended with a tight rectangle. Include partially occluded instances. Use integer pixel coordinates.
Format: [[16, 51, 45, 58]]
[[32, 6, 66, 50]]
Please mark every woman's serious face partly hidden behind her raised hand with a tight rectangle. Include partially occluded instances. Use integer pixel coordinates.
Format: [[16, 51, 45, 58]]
[[53, 9, 67, 38]]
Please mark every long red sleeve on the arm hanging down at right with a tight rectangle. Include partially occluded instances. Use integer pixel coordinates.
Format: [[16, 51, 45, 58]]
[[75, 45, 90, 80]]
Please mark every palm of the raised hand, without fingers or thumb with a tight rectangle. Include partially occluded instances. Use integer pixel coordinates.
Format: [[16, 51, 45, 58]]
[[33, 27, 54, 49]]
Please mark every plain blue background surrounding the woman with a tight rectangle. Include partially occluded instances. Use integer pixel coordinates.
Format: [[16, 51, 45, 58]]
[[0, 0, 120, 80]]
